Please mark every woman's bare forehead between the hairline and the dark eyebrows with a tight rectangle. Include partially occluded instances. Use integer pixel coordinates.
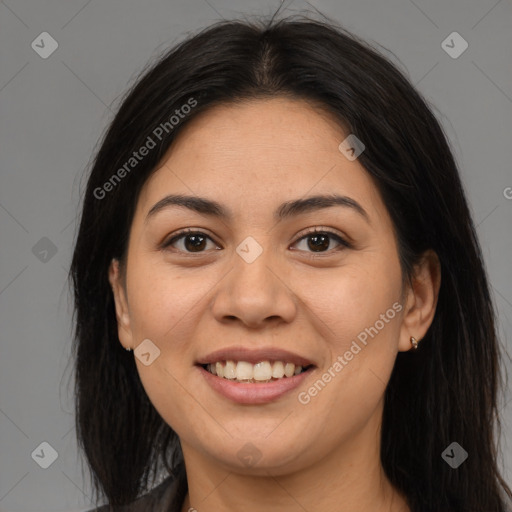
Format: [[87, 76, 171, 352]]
[[137, 98, 385, 223]]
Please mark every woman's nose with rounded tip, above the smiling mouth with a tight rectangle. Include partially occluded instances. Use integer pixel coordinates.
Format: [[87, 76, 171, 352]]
[[212, 249, 298, 329]]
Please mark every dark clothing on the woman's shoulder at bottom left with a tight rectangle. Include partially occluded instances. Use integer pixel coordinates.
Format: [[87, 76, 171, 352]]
[[87, 476, 183, 512]]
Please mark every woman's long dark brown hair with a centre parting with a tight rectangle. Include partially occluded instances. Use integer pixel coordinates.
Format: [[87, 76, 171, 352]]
[[70, 8, 512, 512]]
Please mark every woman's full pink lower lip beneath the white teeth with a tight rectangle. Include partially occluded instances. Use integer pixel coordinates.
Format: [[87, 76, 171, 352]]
[[197, 366, 313, 405]]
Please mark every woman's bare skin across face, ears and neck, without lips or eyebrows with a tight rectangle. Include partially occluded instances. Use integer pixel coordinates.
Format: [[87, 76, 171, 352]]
[[110, 98, 440, 512]]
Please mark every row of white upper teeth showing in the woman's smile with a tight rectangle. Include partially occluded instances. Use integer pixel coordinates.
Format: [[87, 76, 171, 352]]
[[206, 361, 302, 381]]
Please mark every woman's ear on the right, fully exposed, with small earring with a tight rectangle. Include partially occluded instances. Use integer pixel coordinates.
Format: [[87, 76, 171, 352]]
[[398, 249, 441, 352]]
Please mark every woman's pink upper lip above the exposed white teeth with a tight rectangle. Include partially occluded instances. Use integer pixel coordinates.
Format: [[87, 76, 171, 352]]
[[197, 347, 314, 367]]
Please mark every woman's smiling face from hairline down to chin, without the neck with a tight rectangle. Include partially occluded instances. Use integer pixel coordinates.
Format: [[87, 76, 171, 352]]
[[110, 99, 421, 475]]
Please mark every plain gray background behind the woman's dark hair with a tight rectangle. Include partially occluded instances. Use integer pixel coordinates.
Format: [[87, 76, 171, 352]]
[[0, 0, 512, 512]]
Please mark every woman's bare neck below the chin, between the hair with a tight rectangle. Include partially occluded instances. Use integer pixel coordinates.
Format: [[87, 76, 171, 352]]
[[182, 404, 410, 512]]
